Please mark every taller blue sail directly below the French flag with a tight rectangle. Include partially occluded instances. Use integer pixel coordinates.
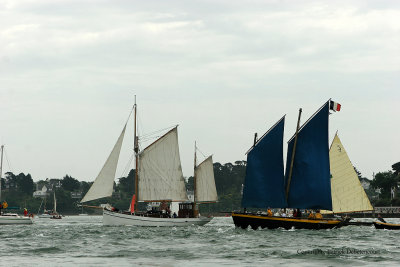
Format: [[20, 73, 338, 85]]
[[286, 101, 332, 210]]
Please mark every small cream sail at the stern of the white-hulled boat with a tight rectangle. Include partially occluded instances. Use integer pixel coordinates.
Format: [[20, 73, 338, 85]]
[[195, 156, 218, 202]]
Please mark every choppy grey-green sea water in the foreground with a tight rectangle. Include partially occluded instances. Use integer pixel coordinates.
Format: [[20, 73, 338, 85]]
[[0, 216, 400, 266]]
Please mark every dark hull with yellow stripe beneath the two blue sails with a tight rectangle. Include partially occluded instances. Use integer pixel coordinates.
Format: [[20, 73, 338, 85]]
[[232, 213, 345, 230]]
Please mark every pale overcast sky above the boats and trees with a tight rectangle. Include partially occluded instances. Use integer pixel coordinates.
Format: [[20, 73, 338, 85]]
[[0, 0, 400, 181]]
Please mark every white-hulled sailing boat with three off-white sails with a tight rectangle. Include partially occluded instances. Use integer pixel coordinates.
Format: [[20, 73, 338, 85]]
[[81, 100, 216, 226]]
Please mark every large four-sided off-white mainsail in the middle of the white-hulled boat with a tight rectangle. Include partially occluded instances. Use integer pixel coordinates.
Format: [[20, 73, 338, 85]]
[[138, 127, 188, 201]]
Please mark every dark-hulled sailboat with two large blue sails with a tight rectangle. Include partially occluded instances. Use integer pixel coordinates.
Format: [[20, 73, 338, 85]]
[[232, 100, 344, 229]]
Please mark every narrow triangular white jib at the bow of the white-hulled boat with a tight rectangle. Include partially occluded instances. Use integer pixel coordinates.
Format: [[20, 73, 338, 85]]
[[81, 124, 126, 203]]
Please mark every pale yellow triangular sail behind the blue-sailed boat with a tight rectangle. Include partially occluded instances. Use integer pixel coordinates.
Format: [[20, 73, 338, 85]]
[[325, 135, 373, 213]]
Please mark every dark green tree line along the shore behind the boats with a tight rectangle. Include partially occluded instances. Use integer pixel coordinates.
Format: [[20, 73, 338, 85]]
[[1, 161, 400, 214]]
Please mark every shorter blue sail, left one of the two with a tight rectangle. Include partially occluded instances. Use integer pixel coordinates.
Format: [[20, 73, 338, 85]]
[[242, 117, 287, 208]]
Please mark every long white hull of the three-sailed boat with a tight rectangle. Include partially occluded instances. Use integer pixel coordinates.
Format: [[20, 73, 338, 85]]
[[103, 210, 212, 227]]
